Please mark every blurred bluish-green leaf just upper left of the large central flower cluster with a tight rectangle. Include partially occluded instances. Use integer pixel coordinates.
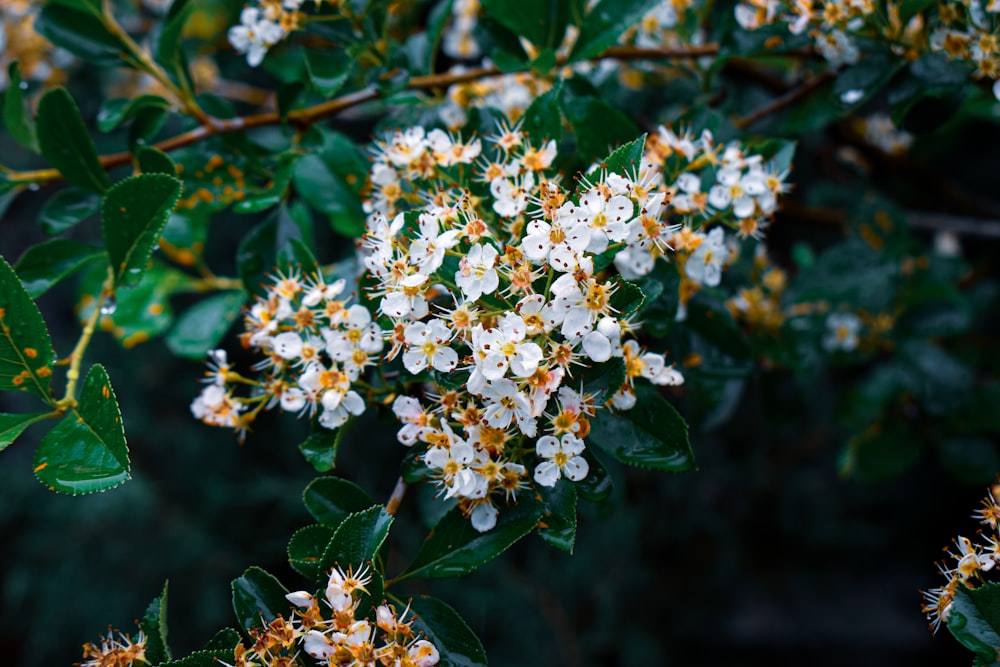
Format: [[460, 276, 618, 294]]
[[293, 154, 365, 238]]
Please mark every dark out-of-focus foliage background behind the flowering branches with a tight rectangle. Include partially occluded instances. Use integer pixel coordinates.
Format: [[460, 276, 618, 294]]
[[0, 1, 1000, 667]]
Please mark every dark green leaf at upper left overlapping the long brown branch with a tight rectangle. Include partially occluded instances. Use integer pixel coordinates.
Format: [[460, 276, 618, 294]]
[[36, 87, 111, 193]]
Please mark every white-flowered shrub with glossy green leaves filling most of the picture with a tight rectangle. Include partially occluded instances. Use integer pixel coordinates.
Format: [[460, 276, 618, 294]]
[[0, 0, 1000, 667]]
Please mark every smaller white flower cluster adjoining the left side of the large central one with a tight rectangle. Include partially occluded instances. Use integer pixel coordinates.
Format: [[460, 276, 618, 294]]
[[191, 271, 383, 433]]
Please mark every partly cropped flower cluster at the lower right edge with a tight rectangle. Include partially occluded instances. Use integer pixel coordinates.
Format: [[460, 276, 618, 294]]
[[922, 483, 1000, 632]]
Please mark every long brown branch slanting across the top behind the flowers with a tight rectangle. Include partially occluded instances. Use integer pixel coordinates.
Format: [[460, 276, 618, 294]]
[[7, 44, 719, 185]]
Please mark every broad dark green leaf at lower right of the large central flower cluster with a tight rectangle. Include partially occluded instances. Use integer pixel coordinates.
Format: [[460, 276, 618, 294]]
[[588, 385, 695, 472]]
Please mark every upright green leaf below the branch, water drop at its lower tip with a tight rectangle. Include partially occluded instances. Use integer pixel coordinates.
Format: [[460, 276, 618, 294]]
[[101, 174, 181, 287]]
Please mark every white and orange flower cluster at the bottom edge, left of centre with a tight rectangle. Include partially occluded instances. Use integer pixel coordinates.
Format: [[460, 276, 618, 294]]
[[230, 568, 441, 667]]
